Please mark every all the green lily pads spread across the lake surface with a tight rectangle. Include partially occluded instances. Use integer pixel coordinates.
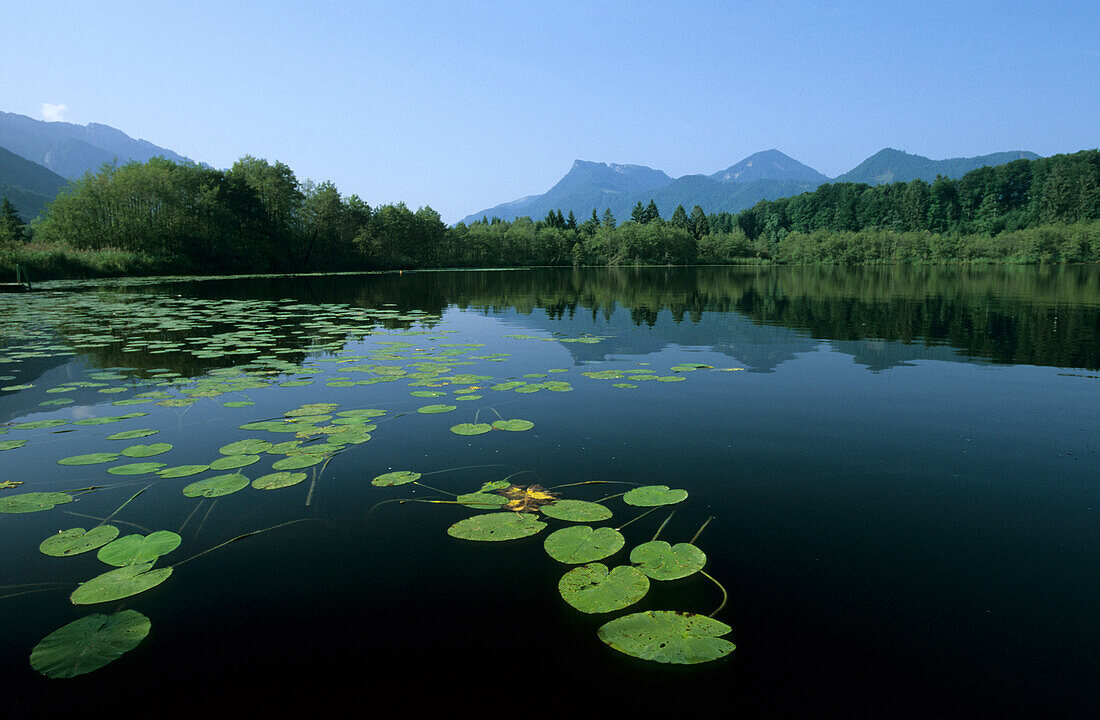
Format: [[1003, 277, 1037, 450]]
[[0, 283, 737, 677]]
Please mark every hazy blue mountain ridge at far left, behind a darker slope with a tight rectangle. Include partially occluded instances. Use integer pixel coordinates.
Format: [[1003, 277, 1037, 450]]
[[0, 112, 190, 179]]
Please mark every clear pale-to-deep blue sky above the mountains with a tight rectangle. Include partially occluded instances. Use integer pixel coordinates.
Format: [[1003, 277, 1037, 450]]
[[0, 0, 1100, 222]]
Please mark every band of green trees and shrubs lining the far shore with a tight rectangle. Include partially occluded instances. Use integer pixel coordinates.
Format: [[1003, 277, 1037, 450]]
[[0, 149, 1100, 280]]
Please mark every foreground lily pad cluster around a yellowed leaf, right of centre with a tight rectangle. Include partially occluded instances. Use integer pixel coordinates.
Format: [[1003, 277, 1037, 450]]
[[372, 470, 735, 665]]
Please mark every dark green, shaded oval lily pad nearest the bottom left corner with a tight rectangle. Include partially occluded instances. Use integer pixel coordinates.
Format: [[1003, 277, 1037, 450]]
[[31, 610, 152, 678]]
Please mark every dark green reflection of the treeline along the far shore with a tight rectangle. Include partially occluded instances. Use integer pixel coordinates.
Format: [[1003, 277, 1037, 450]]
[[79, 265, 1100, 372]]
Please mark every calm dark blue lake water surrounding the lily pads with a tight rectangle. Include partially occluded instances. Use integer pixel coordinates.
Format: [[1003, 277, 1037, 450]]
[[0, 266, 1100, 718]]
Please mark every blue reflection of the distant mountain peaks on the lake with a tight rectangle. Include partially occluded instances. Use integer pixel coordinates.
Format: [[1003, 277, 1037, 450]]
[[493, 307, 981, 373]]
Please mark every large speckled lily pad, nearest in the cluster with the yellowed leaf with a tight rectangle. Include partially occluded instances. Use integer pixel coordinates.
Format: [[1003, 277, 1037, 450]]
[[597, 610, 736, 665]]
